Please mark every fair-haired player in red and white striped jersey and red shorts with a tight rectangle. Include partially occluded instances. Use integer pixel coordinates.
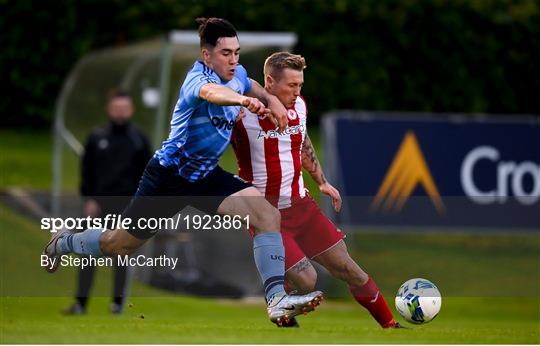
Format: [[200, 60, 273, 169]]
[[232, 52, 400, 328]]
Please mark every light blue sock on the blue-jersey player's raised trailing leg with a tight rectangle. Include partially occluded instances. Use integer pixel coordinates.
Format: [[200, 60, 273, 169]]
[[56, 228, 103, 257]]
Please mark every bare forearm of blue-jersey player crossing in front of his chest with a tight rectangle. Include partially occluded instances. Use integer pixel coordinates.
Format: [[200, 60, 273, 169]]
[[199, 83, 270, 115]]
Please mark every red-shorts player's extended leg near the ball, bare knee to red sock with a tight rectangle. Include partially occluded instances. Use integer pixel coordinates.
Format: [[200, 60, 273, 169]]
[[313, 240, 397, 328]]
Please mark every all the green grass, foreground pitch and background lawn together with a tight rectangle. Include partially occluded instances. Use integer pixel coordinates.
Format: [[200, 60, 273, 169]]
[[0, 130, 540, 344]]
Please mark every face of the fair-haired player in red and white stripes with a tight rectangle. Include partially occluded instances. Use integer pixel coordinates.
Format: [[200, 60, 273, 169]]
[[268, 68, 304, 108]]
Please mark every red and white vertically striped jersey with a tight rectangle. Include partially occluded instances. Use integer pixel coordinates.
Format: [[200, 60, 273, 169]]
[[232, 97, 307, 209]]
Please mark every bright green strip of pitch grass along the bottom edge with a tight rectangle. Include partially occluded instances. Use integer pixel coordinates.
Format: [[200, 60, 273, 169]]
[[0, 297, 540, 344]]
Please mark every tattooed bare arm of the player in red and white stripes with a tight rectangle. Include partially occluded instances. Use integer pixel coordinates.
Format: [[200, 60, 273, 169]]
[[301, 134, 341, 212]]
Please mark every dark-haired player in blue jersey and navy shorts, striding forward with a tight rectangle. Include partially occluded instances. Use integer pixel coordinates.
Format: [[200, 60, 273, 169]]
[[44, 18, 322, 324]]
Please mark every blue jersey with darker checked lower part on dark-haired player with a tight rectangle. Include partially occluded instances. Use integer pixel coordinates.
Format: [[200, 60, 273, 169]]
[[154, 61, 251, 182]]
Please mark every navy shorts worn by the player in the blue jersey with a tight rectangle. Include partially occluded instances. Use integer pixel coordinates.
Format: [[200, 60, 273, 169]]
[[122, 158, 251, 239]]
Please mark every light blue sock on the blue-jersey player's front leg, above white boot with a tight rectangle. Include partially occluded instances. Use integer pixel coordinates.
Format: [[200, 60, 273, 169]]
[[253, 232, 285, 300]]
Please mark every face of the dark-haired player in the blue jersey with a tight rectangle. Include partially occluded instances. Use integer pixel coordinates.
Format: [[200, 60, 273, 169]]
[[203, 37, 240, 81]]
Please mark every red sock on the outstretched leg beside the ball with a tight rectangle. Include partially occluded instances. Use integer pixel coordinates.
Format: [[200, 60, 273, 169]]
[[349, 277, 396, 328]]
